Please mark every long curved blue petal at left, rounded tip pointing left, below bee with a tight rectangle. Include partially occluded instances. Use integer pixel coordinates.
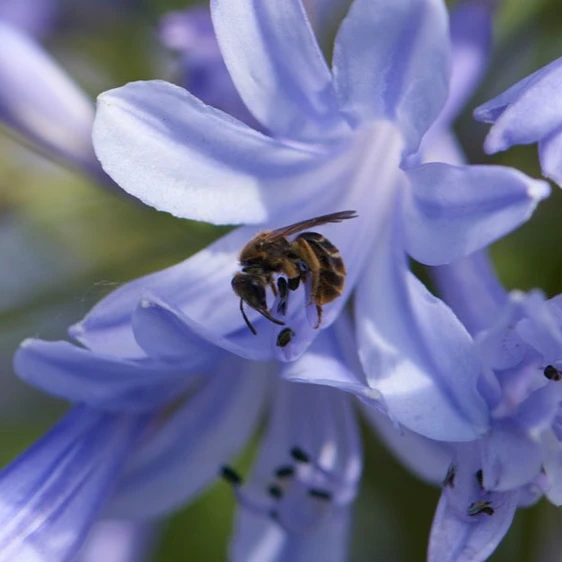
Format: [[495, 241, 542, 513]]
[[14, 340, 212, 412]]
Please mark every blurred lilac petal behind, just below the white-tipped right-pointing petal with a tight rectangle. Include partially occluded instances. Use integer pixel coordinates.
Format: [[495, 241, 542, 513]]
[[431, 250, 507, 335]]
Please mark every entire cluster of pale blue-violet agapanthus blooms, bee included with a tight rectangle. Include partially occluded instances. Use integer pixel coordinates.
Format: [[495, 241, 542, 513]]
[[0, 0, 562, 562]]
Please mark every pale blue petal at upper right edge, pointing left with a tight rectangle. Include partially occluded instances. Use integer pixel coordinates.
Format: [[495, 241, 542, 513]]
[[474, 58, 562, 153]]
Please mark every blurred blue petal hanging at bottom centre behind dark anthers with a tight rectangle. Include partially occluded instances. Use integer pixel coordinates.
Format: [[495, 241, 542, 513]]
[[230, 383, 361, 562]]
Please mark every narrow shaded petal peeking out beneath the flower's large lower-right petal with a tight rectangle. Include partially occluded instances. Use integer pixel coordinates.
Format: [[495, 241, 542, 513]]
[[361, 405, 453, 484]]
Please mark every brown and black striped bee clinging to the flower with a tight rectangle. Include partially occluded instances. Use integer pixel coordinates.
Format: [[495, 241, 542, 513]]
[[232, 211, 357, 335]]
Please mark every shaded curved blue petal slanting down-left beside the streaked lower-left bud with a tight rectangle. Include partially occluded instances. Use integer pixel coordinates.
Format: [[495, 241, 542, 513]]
[[108, 358, 271, 518]]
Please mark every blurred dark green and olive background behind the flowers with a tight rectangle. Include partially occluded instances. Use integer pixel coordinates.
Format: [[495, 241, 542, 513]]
[[0, 0, 562, 562]]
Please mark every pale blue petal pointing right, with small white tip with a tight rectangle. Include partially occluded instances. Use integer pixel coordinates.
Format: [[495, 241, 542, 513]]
[[402, 163, 550, 265]]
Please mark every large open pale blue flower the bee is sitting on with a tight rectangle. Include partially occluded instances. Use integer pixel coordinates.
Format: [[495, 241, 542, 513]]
[[93, 0, 548, 440]]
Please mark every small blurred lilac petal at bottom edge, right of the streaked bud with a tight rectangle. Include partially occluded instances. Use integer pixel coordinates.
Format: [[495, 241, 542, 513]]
[[73, 520, 157, 562]]
